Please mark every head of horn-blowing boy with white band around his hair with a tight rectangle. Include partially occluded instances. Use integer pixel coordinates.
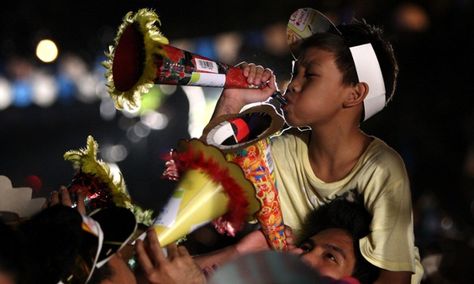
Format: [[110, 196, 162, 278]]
[[284, 17, 398, 128]]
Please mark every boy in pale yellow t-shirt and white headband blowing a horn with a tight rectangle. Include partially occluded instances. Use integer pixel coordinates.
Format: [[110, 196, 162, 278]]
[[214, 18, 422, 283]]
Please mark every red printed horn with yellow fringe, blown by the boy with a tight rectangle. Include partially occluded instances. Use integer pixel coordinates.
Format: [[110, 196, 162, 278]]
[[104, 9, 257, 108]]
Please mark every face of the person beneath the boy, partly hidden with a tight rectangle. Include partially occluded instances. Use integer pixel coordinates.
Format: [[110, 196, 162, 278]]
[[300, 229, 356, 279]]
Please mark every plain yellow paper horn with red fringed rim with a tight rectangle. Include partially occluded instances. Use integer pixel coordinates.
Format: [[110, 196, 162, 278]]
[[153, 139, 260, 246]]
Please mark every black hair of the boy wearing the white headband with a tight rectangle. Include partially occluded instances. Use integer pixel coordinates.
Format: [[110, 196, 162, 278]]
[[300, 19, 398, 112]]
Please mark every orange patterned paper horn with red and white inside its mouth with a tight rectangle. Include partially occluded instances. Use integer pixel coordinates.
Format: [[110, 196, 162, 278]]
[[201, 104, 287, 250]]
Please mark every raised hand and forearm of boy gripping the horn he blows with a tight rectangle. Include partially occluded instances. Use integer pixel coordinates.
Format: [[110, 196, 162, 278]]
[[212, 63, 277, 118]]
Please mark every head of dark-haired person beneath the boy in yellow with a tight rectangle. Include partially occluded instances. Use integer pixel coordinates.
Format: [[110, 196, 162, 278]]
[[299, 192, 379, 283]]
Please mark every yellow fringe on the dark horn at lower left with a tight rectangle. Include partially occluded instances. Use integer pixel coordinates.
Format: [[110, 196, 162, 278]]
[[64, 135, 153, 226]]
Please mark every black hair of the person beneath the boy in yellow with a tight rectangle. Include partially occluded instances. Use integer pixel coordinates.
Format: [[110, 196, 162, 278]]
[[301, 193, 380, 283]]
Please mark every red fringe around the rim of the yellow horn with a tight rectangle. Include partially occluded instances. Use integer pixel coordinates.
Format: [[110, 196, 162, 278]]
[[171, 147, 249, 231]]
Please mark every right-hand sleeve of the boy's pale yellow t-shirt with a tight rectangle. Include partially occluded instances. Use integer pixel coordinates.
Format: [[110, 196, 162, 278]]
[[359, 160, 415, 272]]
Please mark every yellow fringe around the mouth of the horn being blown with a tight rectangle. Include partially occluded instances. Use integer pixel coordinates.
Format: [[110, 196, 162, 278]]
[[102, 9, 169, 109]]
